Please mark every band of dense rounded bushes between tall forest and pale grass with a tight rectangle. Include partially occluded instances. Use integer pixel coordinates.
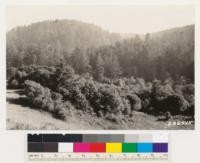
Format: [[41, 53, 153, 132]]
[[7, 65, 194, 119]]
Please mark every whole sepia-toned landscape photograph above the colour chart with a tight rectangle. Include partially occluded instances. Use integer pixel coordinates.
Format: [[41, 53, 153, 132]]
[[6, 4, 195, 130]]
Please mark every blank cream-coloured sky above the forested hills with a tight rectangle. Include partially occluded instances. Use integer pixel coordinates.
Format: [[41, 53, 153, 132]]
[[6, 5, 195, 34]]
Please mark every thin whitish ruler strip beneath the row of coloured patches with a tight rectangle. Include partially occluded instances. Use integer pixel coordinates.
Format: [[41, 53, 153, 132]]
[[28, 153, 168, 161]]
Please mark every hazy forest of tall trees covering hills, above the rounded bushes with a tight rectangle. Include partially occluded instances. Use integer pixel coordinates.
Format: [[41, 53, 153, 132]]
[[7, 20, 194, 82]]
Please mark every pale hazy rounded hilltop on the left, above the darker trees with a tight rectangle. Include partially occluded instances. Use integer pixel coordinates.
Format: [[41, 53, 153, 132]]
[[7, 20, 121, 52]]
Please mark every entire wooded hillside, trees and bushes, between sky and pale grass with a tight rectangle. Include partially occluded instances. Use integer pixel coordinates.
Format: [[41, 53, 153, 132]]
[[6, 20, 194, 129]]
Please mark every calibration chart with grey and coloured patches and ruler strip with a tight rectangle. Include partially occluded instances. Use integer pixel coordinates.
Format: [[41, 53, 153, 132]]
[[27, 134, 169, 163]]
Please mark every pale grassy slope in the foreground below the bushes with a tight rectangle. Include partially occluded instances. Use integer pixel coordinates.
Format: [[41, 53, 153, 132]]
[[6, 90, 194, 130]]
